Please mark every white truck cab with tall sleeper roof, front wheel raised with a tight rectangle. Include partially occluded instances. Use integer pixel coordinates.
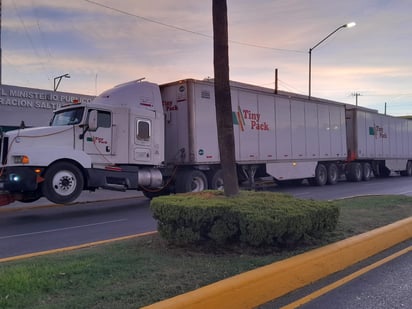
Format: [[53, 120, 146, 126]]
[[0, 80, 164, 203]]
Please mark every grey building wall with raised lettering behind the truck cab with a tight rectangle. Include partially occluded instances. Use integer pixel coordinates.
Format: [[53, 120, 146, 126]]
[[0, 85, 94, 131]]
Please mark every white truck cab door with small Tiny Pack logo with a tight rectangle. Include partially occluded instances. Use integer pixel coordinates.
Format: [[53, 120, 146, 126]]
[[83, 110, 112, 155]]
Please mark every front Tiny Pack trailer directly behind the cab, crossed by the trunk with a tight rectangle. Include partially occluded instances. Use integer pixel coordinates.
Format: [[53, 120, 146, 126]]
[[160, 79, 347, 189]]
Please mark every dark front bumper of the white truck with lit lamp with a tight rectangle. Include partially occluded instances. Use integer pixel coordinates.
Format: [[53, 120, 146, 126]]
[[0, 166, 39, 193]]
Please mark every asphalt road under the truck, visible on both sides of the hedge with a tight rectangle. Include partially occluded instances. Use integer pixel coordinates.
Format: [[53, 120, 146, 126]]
[[0, 173, 412, 258]]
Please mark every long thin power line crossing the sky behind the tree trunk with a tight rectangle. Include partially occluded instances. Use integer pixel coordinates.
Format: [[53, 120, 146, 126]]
[[84, 0, 306, 53]]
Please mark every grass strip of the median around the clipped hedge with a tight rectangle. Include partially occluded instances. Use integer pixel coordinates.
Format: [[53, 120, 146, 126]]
[[0, 196, 412, 308]]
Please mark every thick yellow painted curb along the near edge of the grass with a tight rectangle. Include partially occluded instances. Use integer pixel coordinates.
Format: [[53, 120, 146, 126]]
[[143, 217, 412, 309]]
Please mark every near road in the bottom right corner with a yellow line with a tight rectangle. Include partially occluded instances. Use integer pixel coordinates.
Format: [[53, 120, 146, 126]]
[[258, 239, 412, 309]]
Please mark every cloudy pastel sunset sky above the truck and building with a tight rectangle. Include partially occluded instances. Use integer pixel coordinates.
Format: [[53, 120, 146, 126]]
[[1, 0, 412, 116]]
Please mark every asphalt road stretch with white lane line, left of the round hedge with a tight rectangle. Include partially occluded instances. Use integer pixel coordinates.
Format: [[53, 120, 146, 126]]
[[0, 198, 156, 258]]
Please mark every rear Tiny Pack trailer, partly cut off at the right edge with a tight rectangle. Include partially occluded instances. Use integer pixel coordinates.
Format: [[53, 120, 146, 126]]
[[346, 106, 412, 181]]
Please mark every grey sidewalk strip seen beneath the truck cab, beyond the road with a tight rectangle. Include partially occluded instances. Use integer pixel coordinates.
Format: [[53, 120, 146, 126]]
[[0, 190, 144, 212]]
